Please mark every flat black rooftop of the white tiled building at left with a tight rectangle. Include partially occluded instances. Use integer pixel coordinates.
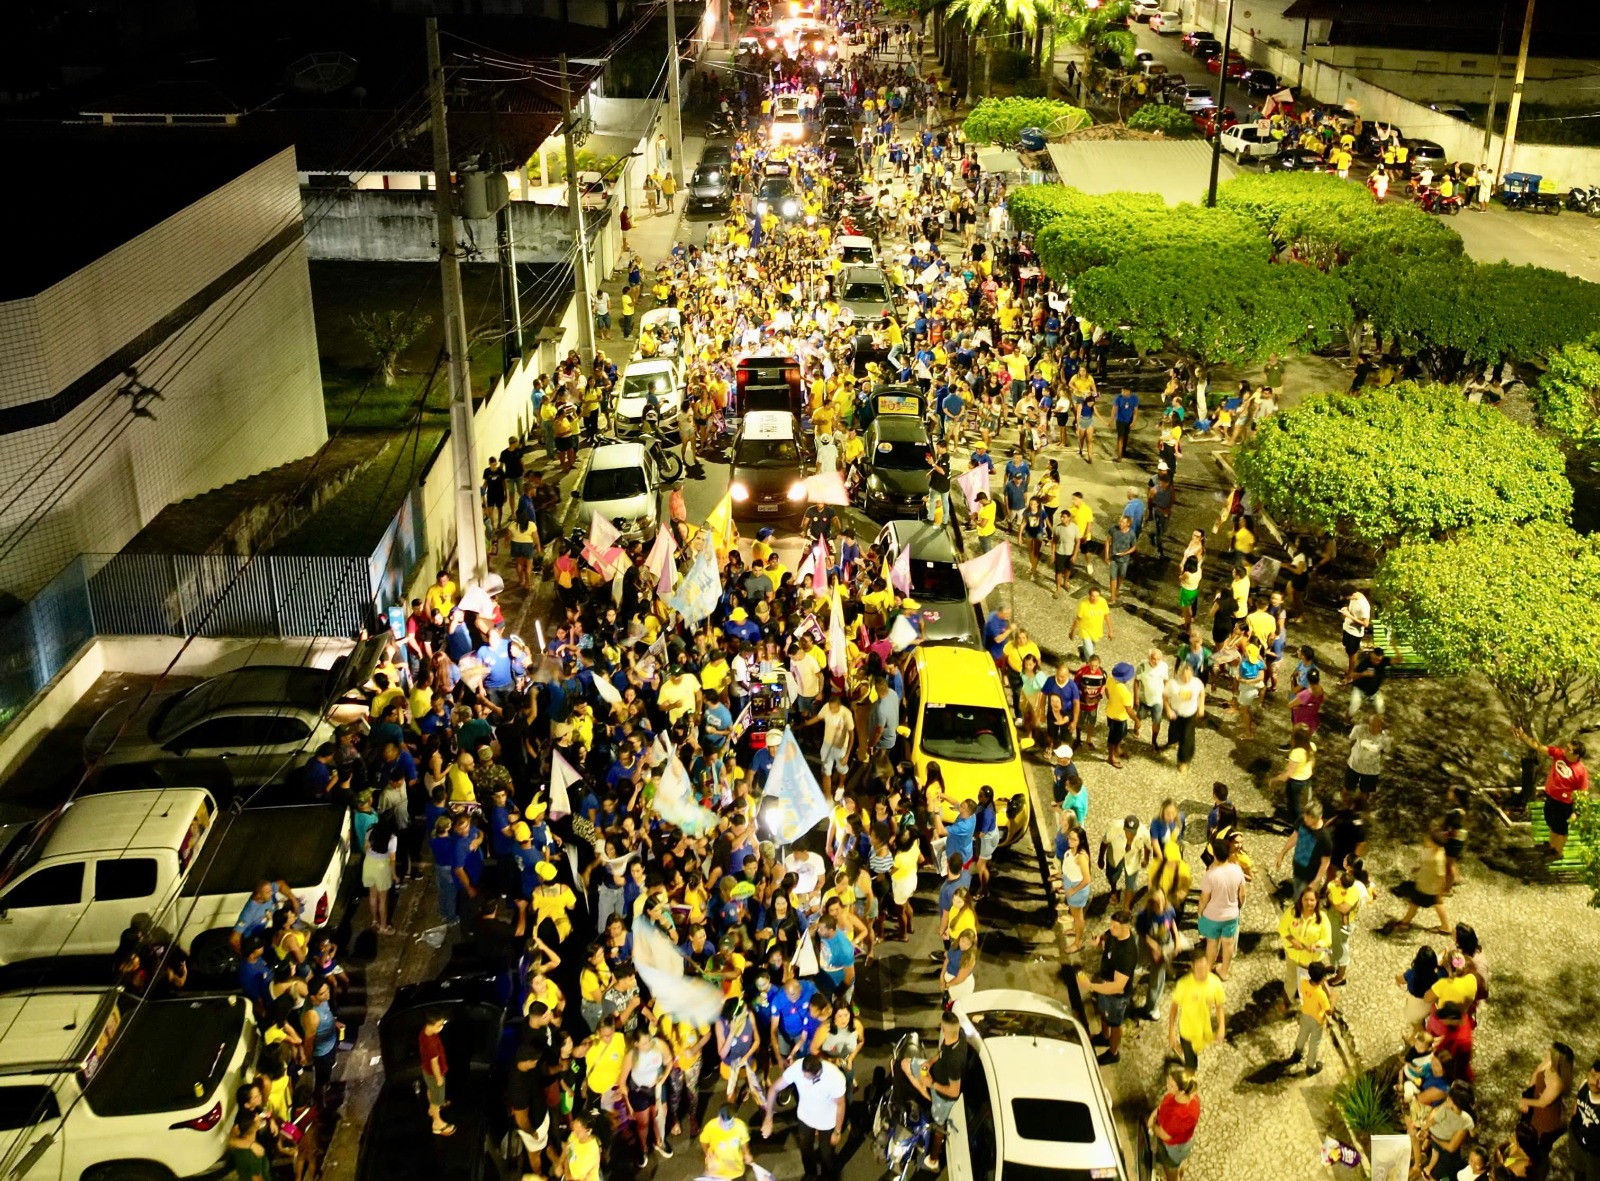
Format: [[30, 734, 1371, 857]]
[[0, 135, 285, 301]]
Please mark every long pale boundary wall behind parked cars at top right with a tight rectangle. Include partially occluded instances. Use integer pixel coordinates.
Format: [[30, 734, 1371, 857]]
[[1194, 0, 1600, 184]]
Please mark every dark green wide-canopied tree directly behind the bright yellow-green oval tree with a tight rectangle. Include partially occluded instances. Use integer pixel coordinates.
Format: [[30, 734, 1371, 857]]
[[1074, 246, 1349, 365]]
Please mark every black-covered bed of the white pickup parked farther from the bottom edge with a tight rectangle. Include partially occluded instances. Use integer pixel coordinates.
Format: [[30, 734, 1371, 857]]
[[184, 803, 349, 898]]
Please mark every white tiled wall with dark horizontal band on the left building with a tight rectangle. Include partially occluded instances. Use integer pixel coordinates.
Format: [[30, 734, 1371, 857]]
[[0, 150, 326, 597]]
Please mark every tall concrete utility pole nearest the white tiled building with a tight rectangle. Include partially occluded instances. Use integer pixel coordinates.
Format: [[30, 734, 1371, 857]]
[[426, 16, 488, 584]]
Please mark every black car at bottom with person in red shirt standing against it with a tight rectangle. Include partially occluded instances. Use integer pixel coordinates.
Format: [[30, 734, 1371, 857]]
[[355, 975, 526, 1181]]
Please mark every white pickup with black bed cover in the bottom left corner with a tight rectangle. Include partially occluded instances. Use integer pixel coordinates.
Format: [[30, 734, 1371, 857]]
[[0, 989, 256, 1181]]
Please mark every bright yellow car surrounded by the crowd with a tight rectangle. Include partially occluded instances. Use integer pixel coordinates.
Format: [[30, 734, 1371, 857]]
[[906, 645, 1029, 845]]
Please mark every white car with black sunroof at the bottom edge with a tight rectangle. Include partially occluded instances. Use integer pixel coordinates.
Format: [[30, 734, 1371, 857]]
[[947, 989, 1138, 1181]]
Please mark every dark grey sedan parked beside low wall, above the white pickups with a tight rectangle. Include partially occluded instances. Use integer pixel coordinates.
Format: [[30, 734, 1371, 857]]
[[83, 634, 389, 787]]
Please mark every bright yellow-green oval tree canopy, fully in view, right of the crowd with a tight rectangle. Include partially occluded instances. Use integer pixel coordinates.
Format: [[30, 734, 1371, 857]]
[[1235, 382, 1574, 544]]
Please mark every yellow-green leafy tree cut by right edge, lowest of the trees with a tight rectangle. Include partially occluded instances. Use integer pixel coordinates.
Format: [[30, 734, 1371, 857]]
[[1376, 522, 1600, 743]]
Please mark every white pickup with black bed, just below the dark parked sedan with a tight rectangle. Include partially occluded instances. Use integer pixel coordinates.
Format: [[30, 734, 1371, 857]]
[[0, 787, 349, 972]]
